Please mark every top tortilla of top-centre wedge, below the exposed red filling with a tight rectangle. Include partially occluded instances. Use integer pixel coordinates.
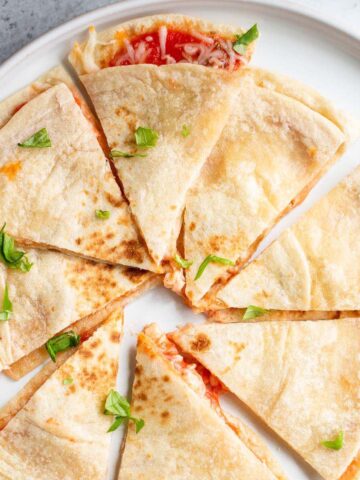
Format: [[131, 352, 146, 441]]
[[81, 63, 241, 265]]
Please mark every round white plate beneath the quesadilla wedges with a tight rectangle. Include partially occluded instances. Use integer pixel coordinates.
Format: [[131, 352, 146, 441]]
[[0, 0, 360, 480]]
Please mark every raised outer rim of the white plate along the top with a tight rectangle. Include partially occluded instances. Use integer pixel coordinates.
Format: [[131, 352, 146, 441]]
[[0, 0, 360, 86]]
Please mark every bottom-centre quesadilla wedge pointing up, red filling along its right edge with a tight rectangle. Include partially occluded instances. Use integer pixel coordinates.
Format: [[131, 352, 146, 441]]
[[119, 325, 284, 480]]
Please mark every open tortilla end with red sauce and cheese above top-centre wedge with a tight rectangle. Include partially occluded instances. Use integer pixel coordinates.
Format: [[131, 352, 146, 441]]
[[69, 14, 257, 75]]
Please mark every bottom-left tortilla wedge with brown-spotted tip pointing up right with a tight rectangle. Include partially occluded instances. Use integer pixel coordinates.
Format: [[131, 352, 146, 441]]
[[0, 310, 122, 480]]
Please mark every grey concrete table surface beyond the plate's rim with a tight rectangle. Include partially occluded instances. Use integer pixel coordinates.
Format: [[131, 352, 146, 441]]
[[0, 0, 360, 64]]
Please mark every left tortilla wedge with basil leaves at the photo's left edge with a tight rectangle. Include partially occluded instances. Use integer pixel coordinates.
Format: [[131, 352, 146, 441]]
[[0, 246, 155, 373]]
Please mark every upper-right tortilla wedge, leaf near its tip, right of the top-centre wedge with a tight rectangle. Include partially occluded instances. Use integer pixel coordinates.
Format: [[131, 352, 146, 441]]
[[184, 68, 347, 309]]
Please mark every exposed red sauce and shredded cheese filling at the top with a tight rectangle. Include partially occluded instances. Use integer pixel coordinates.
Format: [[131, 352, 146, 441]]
[[109, 25, 252, 70]]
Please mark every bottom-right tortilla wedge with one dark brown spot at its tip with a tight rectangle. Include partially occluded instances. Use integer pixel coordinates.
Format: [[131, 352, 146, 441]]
[[171, 319, 360, 480]]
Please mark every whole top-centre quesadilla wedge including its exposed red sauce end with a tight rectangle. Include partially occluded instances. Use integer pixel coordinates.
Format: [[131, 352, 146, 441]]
[[70, 15, 258, 263]]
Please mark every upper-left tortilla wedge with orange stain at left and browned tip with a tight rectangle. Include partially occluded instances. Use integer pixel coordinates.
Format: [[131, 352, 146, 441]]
[[0, 84, 156, 270]]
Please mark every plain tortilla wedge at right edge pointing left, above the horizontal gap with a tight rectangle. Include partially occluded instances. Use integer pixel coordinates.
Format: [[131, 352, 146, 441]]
[[217, 163, 360, 311]]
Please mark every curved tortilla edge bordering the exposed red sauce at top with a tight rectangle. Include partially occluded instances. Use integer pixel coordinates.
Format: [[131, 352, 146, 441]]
[[69, 14, 255, 75]]
